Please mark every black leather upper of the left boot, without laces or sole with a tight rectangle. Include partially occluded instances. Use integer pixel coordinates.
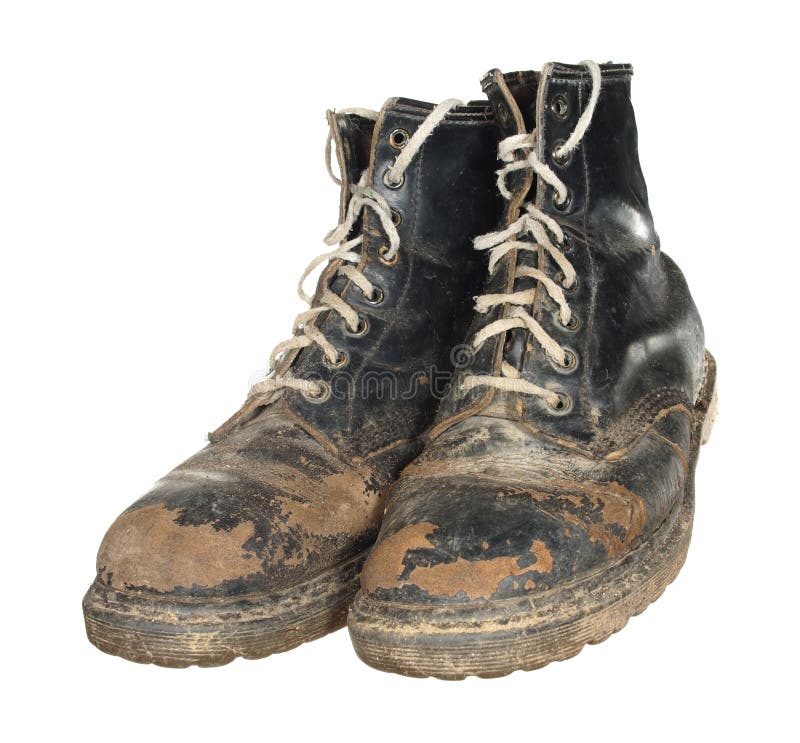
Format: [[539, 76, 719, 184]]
[[97, 99, 502, 598]]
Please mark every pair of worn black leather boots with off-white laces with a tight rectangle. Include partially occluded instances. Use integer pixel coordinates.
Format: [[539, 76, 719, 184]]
[[83, 62, 715, 678]]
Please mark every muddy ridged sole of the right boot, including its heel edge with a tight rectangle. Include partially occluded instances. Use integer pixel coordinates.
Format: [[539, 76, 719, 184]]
[[348, 352, 717, 679]]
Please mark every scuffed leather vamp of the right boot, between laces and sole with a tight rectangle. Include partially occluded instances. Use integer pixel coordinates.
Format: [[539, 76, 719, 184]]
[[361, 410, 690, 604]]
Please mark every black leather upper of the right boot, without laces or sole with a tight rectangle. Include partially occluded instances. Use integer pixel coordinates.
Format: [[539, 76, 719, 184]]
[[362, 64, 704, 604]]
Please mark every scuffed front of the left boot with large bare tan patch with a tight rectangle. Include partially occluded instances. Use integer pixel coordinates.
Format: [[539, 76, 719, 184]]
[[97, 419, 383, 598]]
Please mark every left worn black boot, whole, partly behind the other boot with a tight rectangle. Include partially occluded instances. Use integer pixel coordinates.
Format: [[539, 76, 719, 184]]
[[83, 99, 503, 666]]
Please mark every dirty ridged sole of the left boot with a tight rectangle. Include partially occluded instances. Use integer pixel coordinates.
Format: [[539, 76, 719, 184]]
[[83, 552, 366, 668]]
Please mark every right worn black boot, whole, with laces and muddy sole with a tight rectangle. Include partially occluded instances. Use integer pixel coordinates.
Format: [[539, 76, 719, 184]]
[[349, 63, 715, 678]]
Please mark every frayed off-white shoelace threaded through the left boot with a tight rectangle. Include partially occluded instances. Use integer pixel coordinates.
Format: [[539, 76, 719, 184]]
[[249, 98, 463, 398]]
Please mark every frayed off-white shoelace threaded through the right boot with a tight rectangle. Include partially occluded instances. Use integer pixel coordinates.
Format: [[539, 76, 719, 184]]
[[462, 60, 601, 408]]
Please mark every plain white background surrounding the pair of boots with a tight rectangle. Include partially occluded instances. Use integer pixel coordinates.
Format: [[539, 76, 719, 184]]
[[0, 0, 800, 741]]
